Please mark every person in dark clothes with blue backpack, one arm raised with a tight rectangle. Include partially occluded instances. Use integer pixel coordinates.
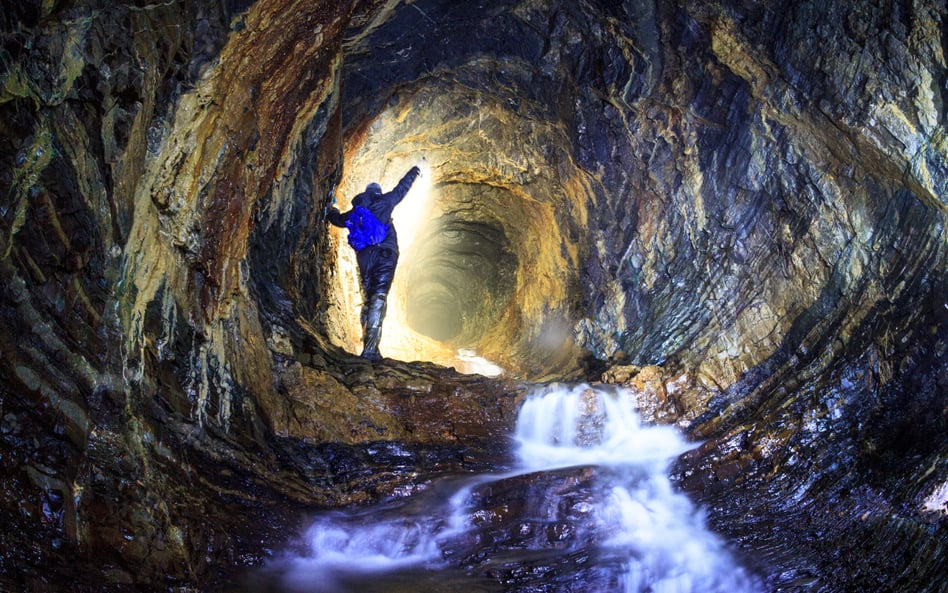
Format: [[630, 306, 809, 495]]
[[328, 166, 421, 360]]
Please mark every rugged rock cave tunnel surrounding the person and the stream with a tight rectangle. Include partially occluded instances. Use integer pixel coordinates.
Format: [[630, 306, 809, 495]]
[[0, 0, 948, 593]]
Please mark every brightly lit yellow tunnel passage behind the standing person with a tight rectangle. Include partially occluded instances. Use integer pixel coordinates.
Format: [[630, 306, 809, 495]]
[[327, 81, 589, 378]]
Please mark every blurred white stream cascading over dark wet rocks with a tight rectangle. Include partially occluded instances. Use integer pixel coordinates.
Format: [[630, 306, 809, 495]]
[[268, 385, 760, 593]]
